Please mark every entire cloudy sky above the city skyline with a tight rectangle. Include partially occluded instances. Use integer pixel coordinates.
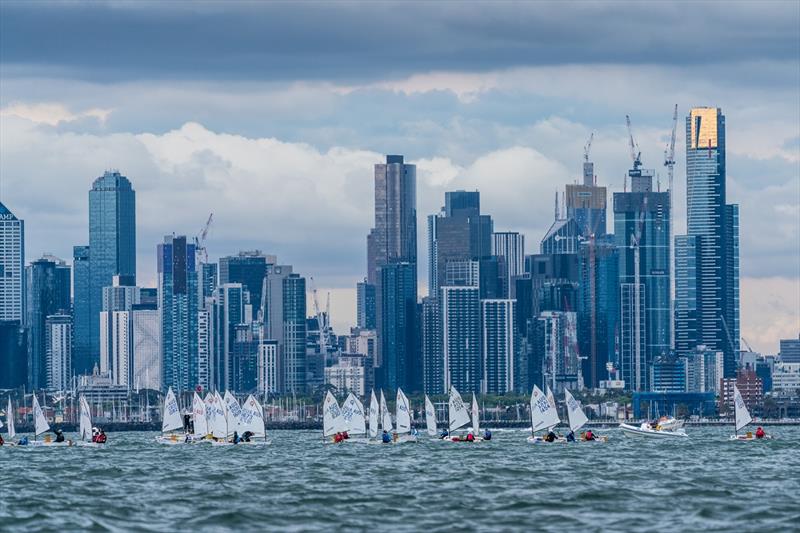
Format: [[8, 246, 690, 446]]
[[0, 1, 800, 353]]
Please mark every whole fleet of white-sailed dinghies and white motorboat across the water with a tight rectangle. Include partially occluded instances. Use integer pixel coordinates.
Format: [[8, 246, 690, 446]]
[[0, 385, 784, 448]]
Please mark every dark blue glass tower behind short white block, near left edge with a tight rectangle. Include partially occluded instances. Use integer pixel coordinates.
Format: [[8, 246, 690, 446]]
[[25, 256, 71, 390]]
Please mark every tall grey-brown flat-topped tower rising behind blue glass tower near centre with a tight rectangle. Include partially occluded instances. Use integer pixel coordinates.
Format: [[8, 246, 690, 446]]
[[367, 155, 417, 286]]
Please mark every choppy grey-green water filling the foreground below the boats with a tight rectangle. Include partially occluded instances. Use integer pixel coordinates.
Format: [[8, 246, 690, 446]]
[[0, 427, 800, 531]]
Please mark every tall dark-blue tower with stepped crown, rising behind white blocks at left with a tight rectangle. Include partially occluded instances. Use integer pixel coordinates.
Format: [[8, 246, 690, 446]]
[[87, 171, 136, 374]]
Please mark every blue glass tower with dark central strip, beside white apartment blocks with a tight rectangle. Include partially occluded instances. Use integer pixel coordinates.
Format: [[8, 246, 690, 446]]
[[157, 235, 200, 391]]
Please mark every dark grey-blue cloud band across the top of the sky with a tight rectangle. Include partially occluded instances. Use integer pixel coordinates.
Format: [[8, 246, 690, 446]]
[[0, 1, 800, 82]]
